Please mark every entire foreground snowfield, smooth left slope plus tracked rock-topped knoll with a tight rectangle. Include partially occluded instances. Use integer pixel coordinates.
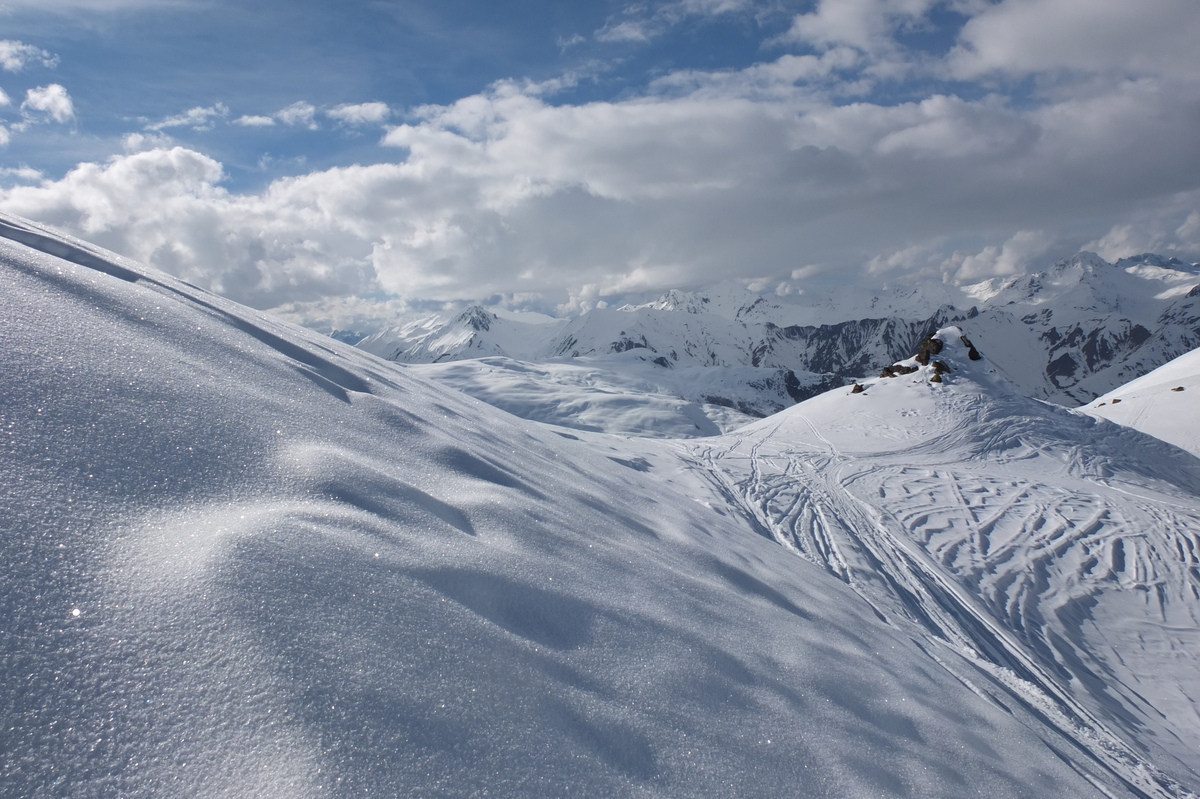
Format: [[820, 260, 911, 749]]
[[0, 211, 1200, 798]]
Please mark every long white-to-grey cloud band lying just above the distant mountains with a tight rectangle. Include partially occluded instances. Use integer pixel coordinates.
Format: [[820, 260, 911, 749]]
[[0, 56, 1200, 307]]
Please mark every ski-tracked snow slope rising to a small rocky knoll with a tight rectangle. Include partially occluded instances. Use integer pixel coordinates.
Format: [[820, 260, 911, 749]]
[[690, 328, 1200, 789]]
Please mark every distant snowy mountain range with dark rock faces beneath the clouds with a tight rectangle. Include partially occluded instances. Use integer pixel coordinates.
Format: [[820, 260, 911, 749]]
[[360, 253, 1200, 435]]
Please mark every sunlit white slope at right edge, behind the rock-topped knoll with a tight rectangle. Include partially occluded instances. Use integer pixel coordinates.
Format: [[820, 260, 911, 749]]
[[1079, 349, 1200, 456]]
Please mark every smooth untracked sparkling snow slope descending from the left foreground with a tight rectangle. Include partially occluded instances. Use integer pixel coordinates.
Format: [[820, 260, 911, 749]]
[[7, 214, 1183, 798]]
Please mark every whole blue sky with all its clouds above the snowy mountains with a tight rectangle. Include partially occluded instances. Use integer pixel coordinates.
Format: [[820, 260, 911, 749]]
[[0, 0, 1200, 328]]
